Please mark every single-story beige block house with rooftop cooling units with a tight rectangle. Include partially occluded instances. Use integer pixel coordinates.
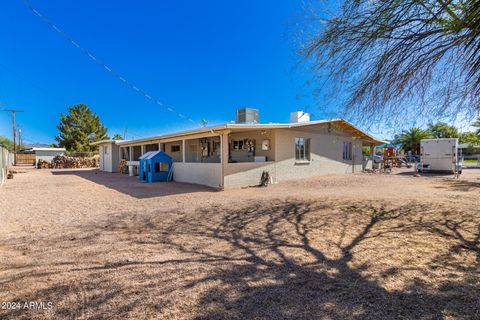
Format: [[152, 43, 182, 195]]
[[94, 109, 385, 188]]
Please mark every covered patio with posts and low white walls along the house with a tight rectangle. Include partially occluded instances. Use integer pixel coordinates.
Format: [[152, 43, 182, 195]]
[[118, 129, 275, 188]]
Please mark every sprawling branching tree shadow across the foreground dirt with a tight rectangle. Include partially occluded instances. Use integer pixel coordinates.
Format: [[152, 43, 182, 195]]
[[0, 200, 480, 319]]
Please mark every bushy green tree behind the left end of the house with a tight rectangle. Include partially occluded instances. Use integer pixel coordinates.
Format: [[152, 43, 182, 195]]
[[55, 104, 108, 152]]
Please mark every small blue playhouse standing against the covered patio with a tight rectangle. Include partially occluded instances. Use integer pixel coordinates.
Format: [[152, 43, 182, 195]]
[[138, 151, 172, 183]]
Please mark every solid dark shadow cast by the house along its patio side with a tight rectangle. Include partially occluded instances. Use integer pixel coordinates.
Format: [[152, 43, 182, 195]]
[[52, 169, 217, 199]]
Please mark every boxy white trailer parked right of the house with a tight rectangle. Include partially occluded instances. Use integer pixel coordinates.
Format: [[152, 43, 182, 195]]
[[420, 138, 460, 173]]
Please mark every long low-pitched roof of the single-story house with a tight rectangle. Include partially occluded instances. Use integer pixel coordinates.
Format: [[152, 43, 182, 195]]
[[113, 118, 386, 145]]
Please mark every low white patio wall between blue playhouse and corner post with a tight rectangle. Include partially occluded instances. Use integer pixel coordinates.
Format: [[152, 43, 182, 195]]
[[173, 162, 222, 188]]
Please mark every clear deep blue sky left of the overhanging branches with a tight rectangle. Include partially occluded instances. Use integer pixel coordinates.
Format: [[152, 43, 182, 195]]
[[0, 0, 324, 143]]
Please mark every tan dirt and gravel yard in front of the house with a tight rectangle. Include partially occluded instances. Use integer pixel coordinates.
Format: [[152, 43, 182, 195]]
[[0, 168, 480, 319]]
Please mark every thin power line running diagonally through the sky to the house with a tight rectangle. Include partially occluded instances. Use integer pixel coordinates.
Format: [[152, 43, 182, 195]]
[[22, 0, 199, 125]]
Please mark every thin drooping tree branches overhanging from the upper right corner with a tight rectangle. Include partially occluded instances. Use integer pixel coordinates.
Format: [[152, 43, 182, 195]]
[[300, 0, 480, 121]]
